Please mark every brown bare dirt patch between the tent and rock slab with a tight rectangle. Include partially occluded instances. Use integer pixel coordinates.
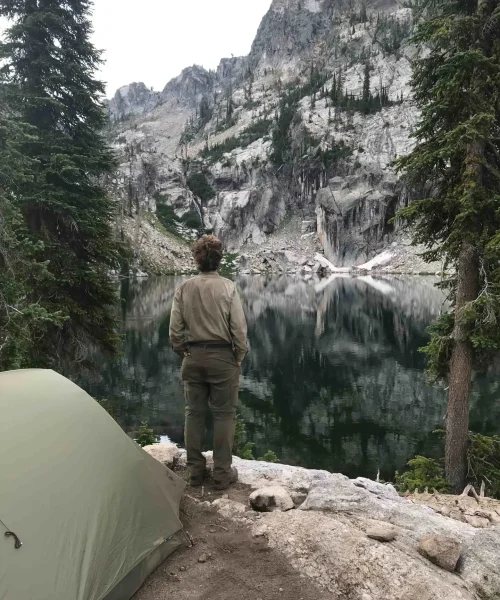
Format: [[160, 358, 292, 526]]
[[133, 484, 340, 600]]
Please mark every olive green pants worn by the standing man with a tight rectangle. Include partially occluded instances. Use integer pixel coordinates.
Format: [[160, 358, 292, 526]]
[[181, 346, 240, 482]]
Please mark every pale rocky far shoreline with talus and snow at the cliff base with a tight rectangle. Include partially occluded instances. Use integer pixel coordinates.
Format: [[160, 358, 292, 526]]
[[124, 218, 442, 279]]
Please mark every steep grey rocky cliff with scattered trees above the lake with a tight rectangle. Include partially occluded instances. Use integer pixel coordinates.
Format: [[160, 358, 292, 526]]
[[109, 0, 424, 267]]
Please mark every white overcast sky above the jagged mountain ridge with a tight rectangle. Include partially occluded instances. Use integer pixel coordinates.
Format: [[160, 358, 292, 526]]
[[93, 0, 271, 96]]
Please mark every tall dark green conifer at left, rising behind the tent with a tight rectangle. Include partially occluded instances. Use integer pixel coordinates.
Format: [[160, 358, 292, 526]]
[[0, 0, 119, 366]]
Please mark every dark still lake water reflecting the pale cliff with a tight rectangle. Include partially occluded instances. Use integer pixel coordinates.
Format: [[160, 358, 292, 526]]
[[79, 276, 500, 478]]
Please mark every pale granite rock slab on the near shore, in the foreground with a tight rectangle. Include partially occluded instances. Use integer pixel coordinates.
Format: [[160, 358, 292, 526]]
[[146, 444, 500, 600]]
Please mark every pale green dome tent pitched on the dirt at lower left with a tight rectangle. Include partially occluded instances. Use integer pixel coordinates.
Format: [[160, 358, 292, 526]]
[[0, 370, 184, 600]]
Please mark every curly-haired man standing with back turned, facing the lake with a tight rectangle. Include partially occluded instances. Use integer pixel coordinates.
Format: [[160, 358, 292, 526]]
[[170, 235, 248, 490]]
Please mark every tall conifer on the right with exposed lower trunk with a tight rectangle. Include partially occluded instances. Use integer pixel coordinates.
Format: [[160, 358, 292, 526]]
[[399, 0, 500, 493]]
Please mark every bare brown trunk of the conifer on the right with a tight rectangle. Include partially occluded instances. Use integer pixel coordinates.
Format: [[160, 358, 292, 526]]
[[445, 241, 479, 494]]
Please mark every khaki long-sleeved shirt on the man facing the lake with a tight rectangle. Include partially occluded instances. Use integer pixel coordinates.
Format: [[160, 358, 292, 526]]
[[170, 272, 248, 362]]
